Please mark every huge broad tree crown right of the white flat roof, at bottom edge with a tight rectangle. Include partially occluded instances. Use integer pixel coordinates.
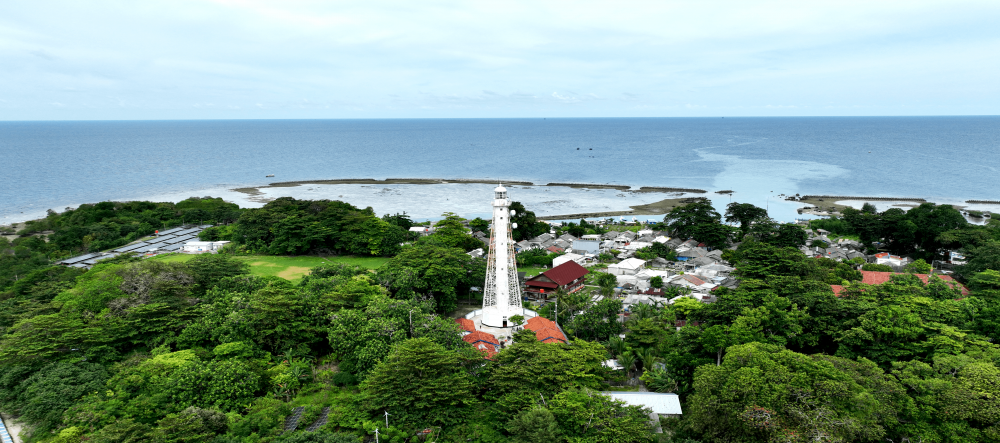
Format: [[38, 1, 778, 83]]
[[685, 343, 909, 442]]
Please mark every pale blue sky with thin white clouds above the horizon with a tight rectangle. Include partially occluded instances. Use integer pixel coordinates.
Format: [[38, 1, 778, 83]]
[[0, 0, 1000, 121]]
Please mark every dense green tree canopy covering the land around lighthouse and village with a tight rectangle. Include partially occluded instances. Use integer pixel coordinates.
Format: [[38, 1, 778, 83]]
[[0, 199, 1000, 443]]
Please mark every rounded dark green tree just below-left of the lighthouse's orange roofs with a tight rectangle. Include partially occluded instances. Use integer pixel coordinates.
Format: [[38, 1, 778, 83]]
[[360, 338, 475, 426]]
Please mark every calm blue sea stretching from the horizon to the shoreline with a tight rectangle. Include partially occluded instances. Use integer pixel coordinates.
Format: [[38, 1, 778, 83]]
[[0, 116, 1000, 225]]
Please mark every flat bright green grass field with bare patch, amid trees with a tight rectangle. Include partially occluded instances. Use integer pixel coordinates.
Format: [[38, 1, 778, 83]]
[[154, 254, 389, 283]]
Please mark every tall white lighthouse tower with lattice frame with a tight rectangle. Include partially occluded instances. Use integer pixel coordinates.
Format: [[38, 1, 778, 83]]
[[482, 185, 524, 328]]
